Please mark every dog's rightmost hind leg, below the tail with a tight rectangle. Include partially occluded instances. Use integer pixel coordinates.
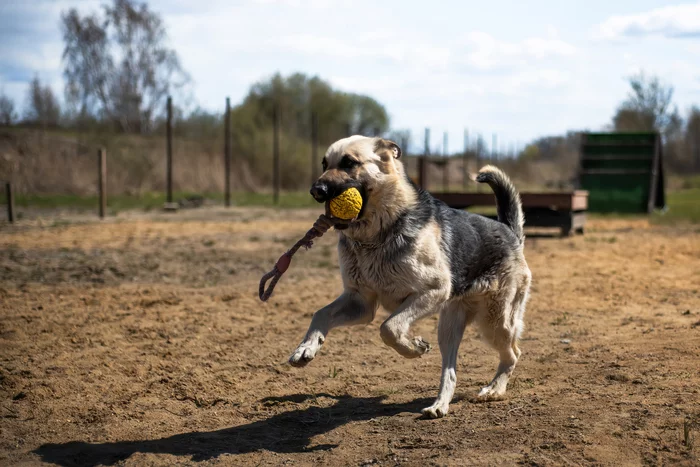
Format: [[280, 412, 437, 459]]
[[477, 270, 530, 401]]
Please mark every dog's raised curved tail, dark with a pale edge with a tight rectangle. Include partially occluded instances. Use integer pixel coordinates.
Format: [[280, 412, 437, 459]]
[[476, 165, 525, 243]]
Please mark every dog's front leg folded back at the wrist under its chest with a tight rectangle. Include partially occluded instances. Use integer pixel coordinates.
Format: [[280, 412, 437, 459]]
[[379, 289, 449, 358]]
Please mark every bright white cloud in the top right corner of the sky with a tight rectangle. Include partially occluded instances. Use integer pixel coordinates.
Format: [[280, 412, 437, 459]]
[[594, 2, 700, 39]]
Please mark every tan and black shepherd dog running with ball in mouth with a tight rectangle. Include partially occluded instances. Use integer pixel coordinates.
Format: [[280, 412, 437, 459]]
[[289, 136, 531, 418]]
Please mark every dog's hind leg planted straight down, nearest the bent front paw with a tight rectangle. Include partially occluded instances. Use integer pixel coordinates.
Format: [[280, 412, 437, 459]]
[[422, 304, 467, 418]]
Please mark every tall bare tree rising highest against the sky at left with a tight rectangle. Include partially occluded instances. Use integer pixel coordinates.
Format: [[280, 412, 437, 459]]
[[61, 0, 189, 132]]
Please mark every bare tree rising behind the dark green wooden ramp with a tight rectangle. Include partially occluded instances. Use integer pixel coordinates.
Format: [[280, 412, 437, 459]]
[[613, 72, 681, 136]]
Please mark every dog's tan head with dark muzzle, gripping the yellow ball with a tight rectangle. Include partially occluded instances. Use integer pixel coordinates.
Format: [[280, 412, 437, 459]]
[[311, 136, 410, 230]]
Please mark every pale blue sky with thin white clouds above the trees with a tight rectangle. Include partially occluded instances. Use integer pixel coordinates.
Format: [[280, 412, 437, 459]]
[[0, 0, 700, 152]]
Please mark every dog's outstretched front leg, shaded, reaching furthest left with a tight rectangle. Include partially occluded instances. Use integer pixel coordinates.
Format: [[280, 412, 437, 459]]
[[289, 290, 377, 366]]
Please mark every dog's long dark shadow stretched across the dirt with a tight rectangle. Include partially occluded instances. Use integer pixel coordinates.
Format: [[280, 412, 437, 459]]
[[34, 394, 430, 466]]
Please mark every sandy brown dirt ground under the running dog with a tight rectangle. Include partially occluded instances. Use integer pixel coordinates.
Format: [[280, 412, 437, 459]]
[[0, 209, 700, 466]]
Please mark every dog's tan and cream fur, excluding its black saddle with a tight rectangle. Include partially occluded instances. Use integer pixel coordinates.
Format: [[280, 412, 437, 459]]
[[289, 136, 531, 417]]
